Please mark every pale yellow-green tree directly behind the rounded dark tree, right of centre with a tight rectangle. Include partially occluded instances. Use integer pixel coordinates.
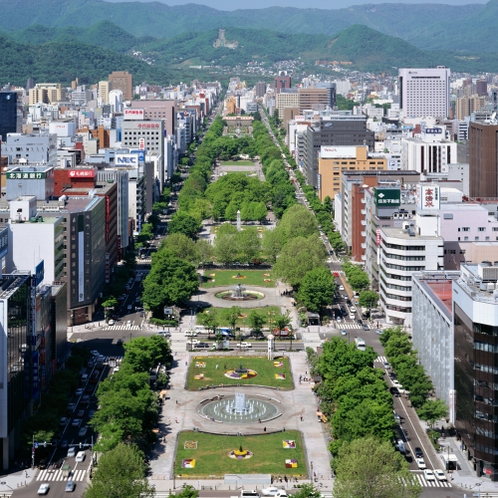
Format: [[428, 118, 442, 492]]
[[273, 237, 327, 289]]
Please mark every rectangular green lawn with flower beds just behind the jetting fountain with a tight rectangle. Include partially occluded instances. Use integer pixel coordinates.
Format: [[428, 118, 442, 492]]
[[187, 355, 293, 391]]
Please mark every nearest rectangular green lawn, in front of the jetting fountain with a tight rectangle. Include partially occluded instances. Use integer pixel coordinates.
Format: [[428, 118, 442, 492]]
[[175, 430, 307, 477]]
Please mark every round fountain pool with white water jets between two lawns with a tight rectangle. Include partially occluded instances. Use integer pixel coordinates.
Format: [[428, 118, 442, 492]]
[[199, 395, 279, 424]]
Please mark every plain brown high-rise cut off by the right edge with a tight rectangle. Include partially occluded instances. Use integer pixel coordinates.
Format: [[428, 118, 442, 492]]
[[469, 121, 498, 197]]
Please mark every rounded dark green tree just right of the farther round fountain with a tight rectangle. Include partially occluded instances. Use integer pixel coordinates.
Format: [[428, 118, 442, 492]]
[[297, 266, 335, 313]]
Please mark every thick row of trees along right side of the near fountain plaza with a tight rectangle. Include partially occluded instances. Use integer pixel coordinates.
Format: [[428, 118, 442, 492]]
[[308, 338, 422, 498]]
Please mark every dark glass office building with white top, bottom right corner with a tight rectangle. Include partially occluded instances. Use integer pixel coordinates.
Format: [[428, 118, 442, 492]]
[[452, 262, 498, 481]]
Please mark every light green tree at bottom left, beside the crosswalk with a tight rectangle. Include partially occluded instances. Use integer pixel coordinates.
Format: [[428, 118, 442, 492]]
[[83, 443, 154, 498]]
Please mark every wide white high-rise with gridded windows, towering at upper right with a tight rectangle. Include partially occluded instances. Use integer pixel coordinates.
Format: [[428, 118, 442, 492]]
[[399, 66, 450, 119]]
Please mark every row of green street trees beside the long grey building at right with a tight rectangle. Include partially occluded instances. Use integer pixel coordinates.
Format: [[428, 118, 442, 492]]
[[380, 327, 448, 425]]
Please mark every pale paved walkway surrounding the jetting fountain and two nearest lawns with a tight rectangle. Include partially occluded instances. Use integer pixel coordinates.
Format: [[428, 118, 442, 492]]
[[150, 352, 332, 494]]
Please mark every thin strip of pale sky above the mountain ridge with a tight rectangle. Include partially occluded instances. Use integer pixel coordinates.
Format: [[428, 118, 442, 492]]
[[106, 0, 487, 11]]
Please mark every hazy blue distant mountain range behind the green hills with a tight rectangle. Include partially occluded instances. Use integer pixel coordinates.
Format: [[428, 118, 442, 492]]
[[0, 0, 486, 52]]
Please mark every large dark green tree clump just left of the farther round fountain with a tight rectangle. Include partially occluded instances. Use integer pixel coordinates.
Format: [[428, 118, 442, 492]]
[[142, 250, 199, 318]]
